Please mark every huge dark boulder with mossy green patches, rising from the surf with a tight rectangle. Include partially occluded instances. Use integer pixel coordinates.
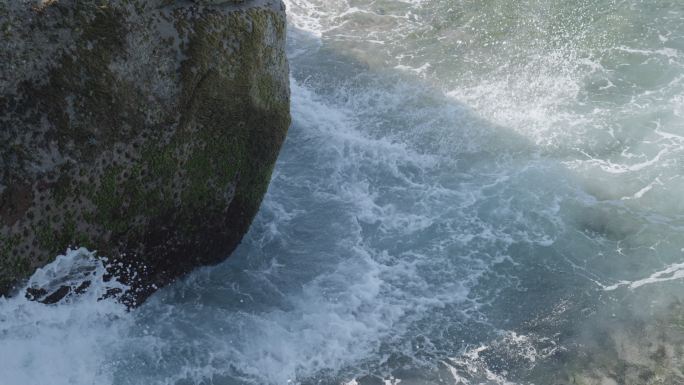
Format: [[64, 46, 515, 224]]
[[0, 0, 290, 304]]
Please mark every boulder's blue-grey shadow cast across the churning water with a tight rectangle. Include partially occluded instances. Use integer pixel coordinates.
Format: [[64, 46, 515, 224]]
[[124, 9, 684, 385]]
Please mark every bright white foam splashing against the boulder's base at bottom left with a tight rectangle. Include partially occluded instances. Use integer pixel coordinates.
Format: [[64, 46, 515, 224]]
[[0, 249, 131, 385]]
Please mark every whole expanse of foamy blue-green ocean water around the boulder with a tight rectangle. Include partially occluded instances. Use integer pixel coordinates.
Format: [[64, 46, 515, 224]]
[[0, 0, 684, 385]]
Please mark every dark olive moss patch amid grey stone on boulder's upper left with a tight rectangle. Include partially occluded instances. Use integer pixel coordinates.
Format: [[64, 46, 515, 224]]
[[50, 2, 144, 159]]
